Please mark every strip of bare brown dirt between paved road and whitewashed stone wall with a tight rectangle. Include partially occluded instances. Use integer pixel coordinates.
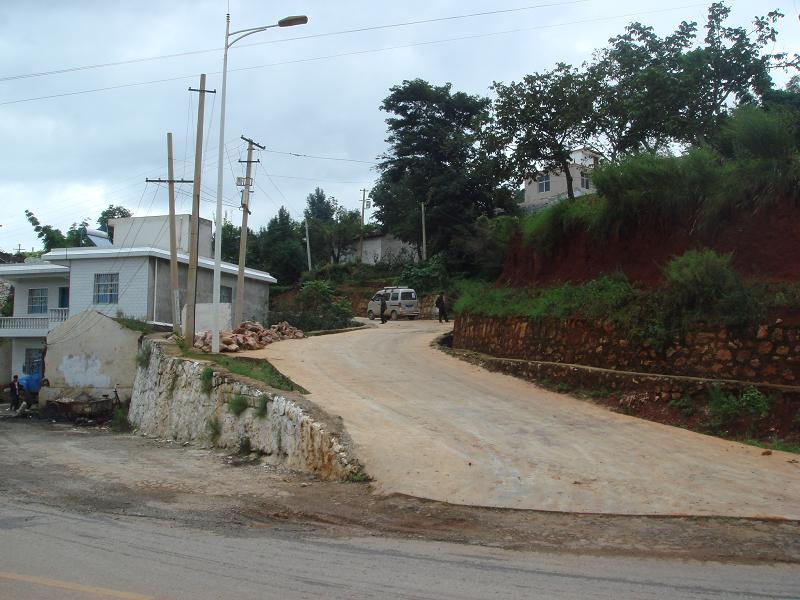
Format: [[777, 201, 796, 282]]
[[0, 419, 800, 562]]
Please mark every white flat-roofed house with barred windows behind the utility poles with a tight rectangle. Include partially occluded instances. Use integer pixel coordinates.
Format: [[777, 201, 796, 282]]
[[0, 215, 276, 381]]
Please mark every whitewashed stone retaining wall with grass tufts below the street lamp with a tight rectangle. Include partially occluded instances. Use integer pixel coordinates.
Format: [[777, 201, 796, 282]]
[[128, 340, 361, 479]]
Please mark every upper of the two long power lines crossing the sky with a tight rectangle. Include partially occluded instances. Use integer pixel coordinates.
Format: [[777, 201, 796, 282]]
[[0, 0, 591, 82]]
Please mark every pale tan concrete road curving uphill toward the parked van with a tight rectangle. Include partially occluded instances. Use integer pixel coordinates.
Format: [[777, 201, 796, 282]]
[[255, 321, 800, 519]]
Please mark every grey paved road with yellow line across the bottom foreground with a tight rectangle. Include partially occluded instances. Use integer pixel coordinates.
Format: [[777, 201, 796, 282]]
[[0, 498, 800, 600]]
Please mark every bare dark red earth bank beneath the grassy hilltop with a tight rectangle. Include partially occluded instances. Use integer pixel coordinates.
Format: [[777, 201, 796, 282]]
[[499, 197, 800, 286]]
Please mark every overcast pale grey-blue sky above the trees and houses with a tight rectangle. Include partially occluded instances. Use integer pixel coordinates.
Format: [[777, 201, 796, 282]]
[[0, 0, 800, 251]]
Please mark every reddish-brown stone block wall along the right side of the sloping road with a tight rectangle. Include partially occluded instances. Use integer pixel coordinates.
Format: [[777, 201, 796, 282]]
[[453, 314, 800, 385]]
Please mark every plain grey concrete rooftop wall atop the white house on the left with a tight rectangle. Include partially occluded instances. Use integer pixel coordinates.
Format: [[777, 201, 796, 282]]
[[108, 215, 213, 258]]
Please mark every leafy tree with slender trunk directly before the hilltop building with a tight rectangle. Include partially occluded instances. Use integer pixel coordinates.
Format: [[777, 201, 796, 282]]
[[490, 63, 593, 199]]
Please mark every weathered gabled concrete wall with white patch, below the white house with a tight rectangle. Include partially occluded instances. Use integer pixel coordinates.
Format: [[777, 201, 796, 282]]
[[45, 310, 141, 401]]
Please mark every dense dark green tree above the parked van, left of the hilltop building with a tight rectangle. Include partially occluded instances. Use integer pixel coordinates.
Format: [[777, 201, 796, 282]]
[[371, 79, 513, 254]]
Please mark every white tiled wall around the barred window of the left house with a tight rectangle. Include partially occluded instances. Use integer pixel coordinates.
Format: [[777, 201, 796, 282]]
[[65, 256, 150, 320]]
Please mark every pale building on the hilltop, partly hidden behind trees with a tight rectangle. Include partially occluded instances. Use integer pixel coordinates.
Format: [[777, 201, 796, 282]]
[[520, 148, 603, 212]]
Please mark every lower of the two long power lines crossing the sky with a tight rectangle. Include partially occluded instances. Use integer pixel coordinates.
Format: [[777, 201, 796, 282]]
[[0, 3, 706, 106]]
